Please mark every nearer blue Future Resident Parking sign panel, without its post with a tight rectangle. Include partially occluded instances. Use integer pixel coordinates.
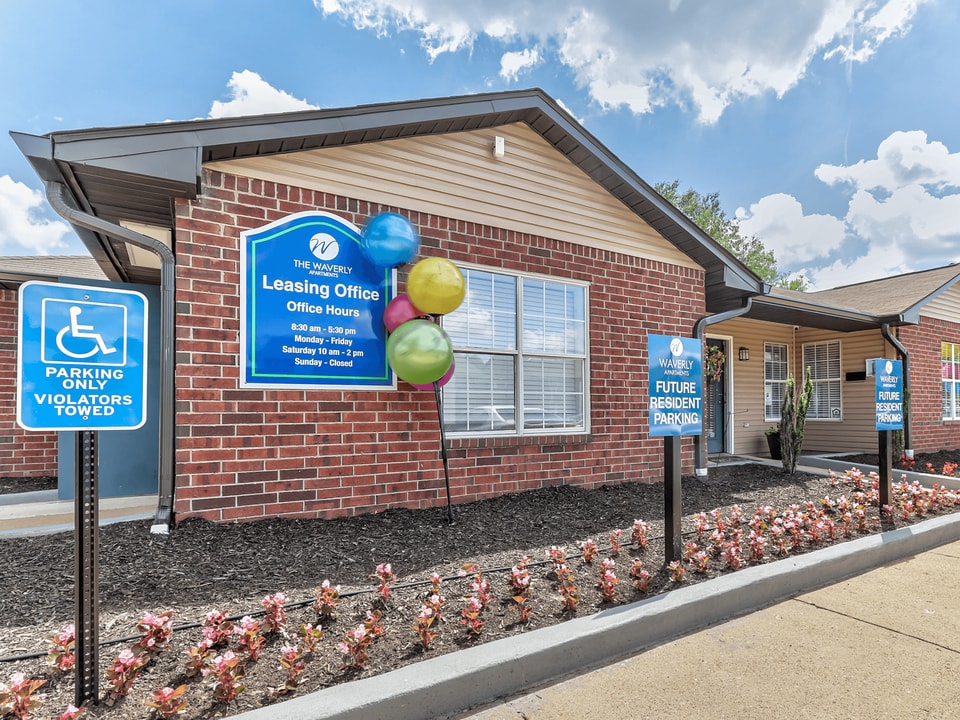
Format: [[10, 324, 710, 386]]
[[647, 335, 703, 437]]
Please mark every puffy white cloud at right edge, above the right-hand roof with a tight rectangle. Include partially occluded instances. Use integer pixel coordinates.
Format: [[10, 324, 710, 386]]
[[736, 131, 960, 289]]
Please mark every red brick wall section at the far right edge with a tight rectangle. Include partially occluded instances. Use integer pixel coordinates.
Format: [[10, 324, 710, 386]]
[[898, 317, 960, 452]]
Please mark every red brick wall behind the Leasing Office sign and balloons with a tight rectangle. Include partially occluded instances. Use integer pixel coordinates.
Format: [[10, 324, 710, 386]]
[[175, 172, 704, 521]]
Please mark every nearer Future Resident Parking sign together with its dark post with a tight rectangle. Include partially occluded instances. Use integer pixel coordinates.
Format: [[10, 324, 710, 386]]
[[647, 335, 703, 564]]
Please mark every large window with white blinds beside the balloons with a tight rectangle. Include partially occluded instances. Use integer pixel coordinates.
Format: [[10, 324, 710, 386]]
[[443, 269, 589, 434]]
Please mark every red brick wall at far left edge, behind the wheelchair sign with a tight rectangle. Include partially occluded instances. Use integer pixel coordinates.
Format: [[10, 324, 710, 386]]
[[0, 290, 57, 478]]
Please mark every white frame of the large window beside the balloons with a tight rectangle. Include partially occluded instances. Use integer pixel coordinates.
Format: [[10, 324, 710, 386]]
[[443, 263, 590, 437]]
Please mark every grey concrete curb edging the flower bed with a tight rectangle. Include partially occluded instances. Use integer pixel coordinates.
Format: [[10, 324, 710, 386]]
[[234, 513, 960, 720]]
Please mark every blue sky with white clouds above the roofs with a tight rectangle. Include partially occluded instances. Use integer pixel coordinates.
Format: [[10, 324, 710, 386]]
[[0, 0, 960, 289]]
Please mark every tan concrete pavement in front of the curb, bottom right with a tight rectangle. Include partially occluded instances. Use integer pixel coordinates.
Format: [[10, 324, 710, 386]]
[[458, 542, 960, 720]]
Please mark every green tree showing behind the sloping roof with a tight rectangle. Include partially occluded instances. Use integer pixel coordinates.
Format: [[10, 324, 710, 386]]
[[654, 180, 807, 290]]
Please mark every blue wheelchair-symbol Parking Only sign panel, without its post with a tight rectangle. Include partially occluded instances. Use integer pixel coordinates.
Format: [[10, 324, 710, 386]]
[[17, 282, 147, 431]]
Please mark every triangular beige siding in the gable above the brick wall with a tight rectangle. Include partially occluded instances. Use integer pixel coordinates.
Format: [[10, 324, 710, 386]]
[[206, 123, 698, 268]]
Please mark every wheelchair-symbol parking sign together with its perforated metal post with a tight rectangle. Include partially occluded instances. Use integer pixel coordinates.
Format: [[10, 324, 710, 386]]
[[17, 282, 147, 706]]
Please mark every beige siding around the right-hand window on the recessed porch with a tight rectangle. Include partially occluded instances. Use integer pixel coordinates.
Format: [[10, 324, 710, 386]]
[[793, 328, 895, 452]]
